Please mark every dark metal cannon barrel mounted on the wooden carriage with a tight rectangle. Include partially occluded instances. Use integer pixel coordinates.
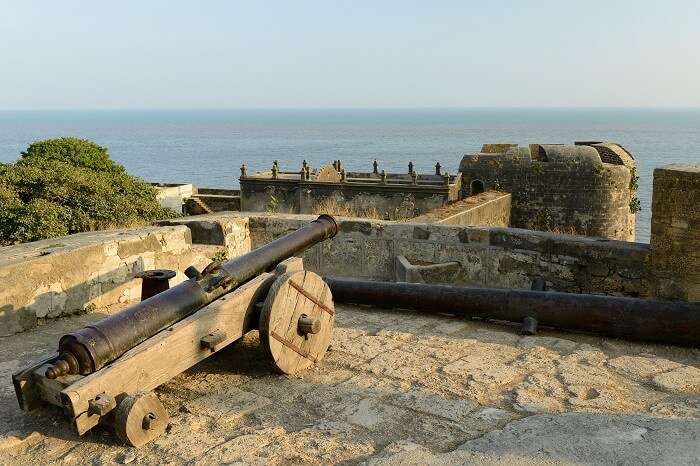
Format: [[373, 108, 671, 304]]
[[46, 215, 338, 379]]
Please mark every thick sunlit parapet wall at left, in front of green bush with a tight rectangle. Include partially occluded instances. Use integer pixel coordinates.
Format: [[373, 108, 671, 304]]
[[0, 226, 216, 335]]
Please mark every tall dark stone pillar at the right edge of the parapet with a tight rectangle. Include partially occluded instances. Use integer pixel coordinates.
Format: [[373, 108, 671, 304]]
[[651, 164, 700, 302]]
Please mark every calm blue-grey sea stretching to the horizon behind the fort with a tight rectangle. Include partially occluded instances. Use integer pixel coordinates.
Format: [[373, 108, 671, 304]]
[[0, 108, 700, 242]]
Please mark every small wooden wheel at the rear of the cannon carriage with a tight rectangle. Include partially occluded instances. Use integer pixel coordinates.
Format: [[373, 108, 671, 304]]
[[114, 393, 169, 447]]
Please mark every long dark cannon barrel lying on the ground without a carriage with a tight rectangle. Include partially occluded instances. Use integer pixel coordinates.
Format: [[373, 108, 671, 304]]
[[325, 277, 700, 346]]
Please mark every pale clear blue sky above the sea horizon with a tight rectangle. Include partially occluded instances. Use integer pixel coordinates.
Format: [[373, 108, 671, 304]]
[[0, 0, 700, 110]]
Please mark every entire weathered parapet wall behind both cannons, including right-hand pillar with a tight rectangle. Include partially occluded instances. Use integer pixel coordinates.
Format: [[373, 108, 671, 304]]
[[0, 165, 700, 335]]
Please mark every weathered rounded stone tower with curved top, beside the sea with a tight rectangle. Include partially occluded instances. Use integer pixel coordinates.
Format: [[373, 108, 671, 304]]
[[460, 143, 635, 241]]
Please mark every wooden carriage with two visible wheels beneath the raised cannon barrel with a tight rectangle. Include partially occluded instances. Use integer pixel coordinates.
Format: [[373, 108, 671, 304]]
[[12, 258, 335, 447]]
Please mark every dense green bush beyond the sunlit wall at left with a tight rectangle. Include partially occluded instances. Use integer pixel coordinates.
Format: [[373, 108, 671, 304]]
[[0, 138, 177, 245]]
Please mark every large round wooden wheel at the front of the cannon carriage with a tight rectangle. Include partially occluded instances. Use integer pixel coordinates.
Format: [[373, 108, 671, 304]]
[[260, 270, 335, 374]]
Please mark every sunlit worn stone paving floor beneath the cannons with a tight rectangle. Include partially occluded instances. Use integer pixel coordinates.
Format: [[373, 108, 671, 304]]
[[0, 306, 700, 465]]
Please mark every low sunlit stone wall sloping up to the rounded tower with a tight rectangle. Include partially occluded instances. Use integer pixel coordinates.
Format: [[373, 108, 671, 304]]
[[411, 191, 511, 227]]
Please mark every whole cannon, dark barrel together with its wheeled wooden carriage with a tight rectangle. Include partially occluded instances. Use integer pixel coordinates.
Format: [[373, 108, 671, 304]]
[[12, 215, 338, 446]]
